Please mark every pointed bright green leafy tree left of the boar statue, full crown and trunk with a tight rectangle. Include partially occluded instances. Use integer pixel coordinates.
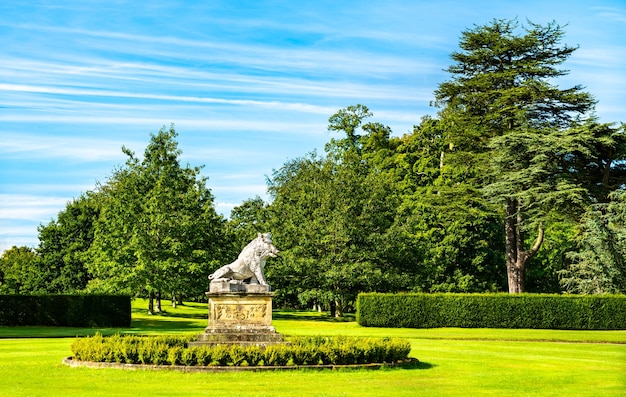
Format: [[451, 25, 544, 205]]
[[90, 127, 229, 312]]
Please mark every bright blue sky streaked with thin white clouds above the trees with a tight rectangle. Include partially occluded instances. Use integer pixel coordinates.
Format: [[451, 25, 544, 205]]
[[0, 0, 626, 252]]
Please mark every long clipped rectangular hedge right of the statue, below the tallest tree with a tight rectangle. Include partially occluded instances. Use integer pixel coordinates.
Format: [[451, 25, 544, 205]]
[[357, 293, 626, 330]]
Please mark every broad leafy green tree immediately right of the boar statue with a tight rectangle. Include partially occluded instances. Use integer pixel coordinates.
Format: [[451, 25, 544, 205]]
[[268, 105, 406, 315]]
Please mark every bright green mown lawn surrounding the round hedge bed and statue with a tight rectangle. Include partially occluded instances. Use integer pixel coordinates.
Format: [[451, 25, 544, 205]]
[[0, 301, 626, 397]]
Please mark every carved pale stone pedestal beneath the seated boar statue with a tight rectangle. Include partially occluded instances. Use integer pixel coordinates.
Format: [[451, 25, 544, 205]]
[[190, 282, 283, 346]]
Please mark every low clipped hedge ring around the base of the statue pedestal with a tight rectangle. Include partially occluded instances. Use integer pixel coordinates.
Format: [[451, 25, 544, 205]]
[[72, 334, 411, 366]]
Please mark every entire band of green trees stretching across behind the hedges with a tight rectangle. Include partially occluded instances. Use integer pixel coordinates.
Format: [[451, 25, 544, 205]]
[[0, 20, 626, 315]]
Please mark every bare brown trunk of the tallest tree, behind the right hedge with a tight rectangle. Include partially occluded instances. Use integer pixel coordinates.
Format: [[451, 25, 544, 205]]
[[504, 198, 544, 294]]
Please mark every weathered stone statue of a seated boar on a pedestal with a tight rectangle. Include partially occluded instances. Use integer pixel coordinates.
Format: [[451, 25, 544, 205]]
[[209, 233, 278, 285]]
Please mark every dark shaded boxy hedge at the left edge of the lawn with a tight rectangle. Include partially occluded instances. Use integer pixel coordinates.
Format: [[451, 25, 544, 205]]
[[0, 295, 131, 327]]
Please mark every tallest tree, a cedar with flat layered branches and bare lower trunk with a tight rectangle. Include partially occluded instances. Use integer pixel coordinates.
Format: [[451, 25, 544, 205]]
[[435, 20, 595, 293]]
